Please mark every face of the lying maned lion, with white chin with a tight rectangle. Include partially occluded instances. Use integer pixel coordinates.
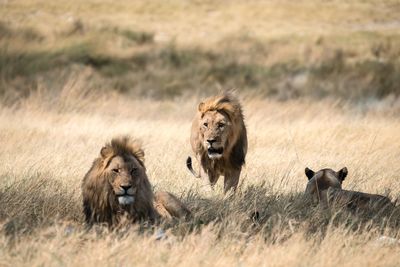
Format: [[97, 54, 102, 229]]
[[105, 155, 143, 205]]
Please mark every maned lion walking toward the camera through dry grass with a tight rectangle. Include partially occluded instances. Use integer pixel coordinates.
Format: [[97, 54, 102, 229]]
[[186, 92, 247, 193]]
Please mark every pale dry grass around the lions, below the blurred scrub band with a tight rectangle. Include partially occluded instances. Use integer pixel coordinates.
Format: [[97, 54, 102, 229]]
[[0, 87, 400, 266]]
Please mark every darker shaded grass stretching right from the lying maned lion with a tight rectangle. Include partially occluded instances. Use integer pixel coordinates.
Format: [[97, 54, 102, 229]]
[[186, 183, 400, 242]]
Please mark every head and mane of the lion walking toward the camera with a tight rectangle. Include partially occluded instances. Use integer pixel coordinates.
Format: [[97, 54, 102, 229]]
[[192, 92, 247, 159]]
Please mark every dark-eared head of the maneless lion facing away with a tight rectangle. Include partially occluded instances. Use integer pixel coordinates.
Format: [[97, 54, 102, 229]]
[[305, 167, 347, 203]]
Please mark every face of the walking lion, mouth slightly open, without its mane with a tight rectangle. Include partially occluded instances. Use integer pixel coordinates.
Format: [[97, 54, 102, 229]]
[[200, 111, 231, 159]]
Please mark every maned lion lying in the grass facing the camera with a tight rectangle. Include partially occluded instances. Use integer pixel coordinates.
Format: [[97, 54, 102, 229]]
[[82, 136, 191, 227]]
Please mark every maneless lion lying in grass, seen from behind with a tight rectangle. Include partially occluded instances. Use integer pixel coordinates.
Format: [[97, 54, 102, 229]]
[[305, 167, 395, 212]]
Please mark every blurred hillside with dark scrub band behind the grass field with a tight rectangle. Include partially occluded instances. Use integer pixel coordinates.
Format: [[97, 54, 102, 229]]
[[0, 0, 400, 103]]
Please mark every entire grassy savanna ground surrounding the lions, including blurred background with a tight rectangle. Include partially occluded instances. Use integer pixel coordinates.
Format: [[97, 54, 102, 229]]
[[0, 0, 400, 266]]
